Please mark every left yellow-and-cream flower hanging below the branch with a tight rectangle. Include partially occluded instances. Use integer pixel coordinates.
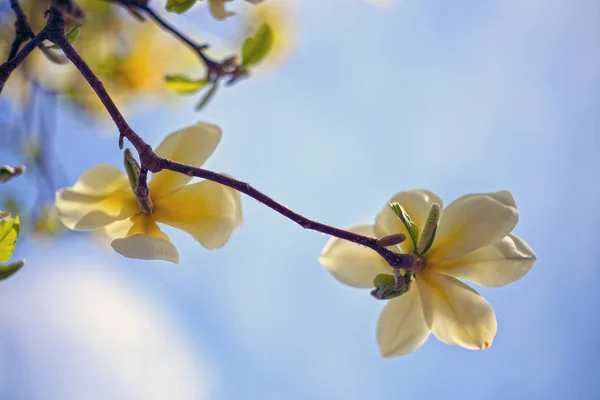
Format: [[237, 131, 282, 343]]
[[56, 122, 242, 263]]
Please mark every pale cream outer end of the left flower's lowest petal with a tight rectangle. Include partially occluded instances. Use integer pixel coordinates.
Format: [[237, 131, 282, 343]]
[[111, 233, 179, 264]]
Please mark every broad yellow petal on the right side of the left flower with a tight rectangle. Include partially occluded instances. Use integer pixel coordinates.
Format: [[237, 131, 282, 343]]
[[153, 181, 242, 249]]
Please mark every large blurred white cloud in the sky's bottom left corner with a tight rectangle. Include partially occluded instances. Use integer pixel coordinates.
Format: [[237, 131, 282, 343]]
[[0, 261, 209, 400]]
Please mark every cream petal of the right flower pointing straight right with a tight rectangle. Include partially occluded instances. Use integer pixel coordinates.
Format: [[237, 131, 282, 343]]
[[431, 234, 536, 287]]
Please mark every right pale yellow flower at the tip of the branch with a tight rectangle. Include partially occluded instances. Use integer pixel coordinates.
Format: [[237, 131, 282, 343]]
[[320, 190, 536, 357]]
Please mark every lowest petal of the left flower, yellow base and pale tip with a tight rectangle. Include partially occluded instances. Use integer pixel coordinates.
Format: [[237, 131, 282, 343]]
[[111, 214, 179, 264]]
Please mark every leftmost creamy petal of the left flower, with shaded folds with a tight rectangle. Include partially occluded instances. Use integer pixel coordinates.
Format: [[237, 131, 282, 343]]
[[55, 165, 139, 231]]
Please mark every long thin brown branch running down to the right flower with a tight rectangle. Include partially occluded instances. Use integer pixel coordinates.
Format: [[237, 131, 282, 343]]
[[48, 7, 413, 272]]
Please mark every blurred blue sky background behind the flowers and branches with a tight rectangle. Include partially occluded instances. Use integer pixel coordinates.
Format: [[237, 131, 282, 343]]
[[0, 0, 600, 399]]
